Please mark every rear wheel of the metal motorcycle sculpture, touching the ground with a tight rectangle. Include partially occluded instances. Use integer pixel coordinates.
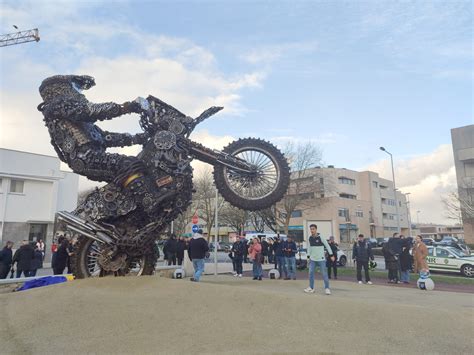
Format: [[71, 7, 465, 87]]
[[71, 236, 157, 279]]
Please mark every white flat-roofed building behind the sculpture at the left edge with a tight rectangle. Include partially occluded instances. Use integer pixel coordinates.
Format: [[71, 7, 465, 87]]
[[0, 148, 79, 254]]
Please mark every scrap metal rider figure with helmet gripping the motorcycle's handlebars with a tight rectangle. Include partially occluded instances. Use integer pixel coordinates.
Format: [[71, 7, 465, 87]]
[[38, 75, 154, 216]]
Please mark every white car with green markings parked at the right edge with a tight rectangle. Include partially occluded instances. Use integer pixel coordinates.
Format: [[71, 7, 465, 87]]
[[426, 246, 474, 277]]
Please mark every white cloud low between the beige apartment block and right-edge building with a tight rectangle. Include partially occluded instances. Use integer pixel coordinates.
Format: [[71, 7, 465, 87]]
[[363, 144, 457, 224]]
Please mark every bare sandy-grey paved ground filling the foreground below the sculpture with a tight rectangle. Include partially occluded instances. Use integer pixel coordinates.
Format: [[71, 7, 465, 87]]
[[0, 276, 474, 354]]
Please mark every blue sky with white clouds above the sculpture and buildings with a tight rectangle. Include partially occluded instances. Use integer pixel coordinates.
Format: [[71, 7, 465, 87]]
[[0, 0, 474, 223]]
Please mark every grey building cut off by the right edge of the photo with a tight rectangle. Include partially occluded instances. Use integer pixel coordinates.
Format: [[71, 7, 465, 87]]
[[451, 125, 474, 243]]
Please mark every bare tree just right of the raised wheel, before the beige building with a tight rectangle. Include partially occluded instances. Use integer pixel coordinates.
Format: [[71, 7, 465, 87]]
[[259, 142, 327, 234]]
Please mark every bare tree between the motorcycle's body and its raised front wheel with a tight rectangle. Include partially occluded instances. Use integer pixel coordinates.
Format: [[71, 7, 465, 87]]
[[193, 170, 228, 241]]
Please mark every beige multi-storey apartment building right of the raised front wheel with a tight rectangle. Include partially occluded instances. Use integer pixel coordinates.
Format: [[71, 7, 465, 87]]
[[289, 166, 410, 243]]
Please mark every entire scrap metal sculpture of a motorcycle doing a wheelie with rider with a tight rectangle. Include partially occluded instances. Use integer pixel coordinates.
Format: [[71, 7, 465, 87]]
[[38, 75, 290, 278]]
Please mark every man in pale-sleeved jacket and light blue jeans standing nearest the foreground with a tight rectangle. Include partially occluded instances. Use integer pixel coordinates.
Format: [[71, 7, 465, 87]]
[[304, 224, 335, 295]]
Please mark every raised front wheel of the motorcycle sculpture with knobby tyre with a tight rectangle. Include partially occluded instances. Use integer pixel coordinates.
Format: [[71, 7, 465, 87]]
[[214, 138, 290, 211]]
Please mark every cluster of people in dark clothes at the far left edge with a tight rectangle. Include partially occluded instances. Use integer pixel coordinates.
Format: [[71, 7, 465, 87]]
[[0, 240, 44, 279]]
